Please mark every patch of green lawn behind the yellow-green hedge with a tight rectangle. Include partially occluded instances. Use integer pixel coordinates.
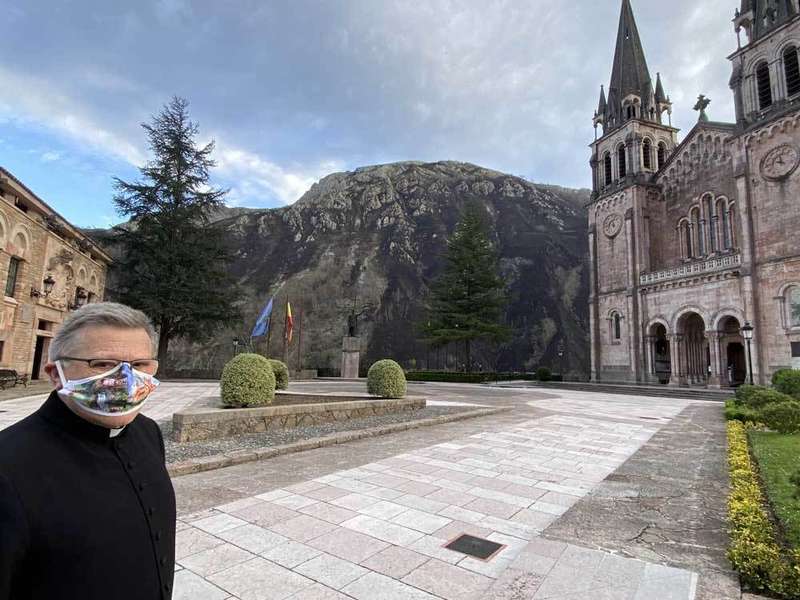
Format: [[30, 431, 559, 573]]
[[750, 431, 800, 549]]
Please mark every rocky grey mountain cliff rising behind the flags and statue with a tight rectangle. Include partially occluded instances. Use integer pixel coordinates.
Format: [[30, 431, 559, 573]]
[[98, 162, 589, 374]]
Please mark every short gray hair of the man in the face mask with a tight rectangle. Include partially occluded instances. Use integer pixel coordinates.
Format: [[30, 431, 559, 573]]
[[48, 302, 157, 362]]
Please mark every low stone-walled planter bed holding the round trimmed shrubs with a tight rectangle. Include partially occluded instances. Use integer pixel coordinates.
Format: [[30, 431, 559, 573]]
[[172, 392, 427, 442]]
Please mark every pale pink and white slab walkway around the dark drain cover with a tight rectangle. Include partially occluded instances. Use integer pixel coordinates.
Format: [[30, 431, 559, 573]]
[[172, 415, 696, 600]]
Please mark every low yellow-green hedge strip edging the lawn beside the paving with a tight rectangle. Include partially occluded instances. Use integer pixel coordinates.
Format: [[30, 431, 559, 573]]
[[728, 421, 800, 599]]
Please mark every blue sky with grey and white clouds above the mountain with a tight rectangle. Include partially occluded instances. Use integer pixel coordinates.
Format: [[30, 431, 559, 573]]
[[0, 0, 738, 227]]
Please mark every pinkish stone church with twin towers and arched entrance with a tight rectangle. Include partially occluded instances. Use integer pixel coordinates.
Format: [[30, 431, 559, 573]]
[[588, 0, 800, 387]]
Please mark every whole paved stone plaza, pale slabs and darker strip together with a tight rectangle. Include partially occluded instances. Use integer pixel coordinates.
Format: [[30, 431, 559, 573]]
[[0, 382, 740, 600]]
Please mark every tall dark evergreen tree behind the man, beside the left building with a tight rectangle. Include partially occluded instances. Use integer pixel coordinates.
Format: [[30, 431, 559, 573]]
[[114, 97, 237, 364]]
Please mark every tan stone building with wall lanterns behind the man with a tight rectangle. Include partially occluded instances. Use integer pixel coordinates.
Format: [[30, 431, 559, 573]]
[[0, 167, 111, 379]]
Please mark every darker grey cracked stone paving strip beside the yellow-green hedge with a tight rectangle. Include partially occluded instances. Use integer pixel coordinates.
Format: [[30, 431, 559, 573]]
[[545, 404, 741, 600]]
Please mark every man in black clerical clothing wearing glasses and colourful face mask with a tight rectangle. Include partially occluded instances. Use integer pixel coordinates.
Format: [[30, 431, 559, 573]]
[[0, 302, 175, 600]]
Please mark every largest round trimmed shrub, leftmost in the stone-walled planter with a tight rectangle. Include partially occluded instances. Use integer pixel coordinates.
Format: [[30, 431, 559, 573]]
[[219, 353, 275, 408]]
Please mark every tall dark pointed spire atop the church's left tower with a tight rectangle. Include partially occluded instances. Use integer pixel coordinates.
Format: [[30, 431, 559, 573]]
[[608, 0, 652, 124]]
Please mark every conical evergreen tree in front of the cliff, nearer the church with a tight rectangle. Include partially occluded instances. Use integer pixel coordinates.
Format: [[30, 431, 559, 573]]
[[422, 204, 511, 371]]
